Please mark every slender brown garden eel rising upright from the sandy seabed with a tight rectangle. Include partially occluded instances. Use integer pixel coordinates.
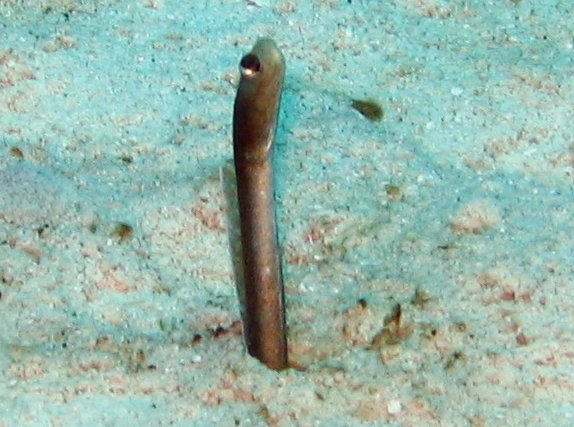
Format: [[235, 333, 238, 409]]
[[233, 39, 287, 370]]
